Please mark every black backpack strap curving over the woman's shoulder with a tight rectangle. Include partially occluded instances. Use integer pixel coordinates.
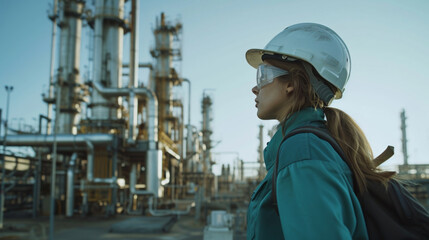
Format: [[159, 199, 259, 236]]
[[271, 126, 350, 215]]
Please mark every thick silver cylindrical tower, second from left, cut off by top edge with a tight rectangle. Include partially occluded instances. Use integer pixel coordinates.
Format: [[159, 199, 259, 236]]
[[88, 0, 125, 129]]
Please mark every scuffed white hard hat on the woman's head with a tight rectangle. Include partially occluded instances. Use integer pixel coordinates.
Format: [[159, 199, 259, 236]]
[[246, 23, 351, 98]]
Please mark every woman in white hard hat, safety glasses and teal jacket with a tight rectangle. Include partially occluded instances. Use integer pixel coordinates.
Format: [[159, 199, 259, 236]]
[[246, 23, 388, 239]]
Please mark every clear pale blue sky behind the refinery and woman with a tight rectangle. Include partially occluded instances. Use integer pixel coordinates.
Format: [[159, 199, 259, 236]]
[[0, 0, 429, 176]]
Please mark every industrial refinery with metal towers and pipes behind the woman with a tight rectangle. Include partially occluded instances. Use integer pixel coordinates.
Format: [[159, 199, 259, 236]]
[[0, 0, 429, 240]]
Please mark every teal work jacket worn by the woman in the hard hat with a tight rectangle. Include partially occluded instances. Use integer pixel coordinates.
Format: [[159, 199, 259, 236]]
[[247, 108, 368, 240]]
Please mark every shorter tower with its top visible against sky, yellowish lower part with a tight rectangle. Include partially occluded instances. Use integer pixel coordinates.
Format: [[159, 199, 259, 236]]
[[149, 13, 184, 201]]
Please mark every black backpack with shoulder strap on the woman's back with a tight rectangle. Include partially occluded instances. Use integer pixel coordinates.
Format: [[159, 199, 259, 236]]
[[271, 126, 429, 240]]
